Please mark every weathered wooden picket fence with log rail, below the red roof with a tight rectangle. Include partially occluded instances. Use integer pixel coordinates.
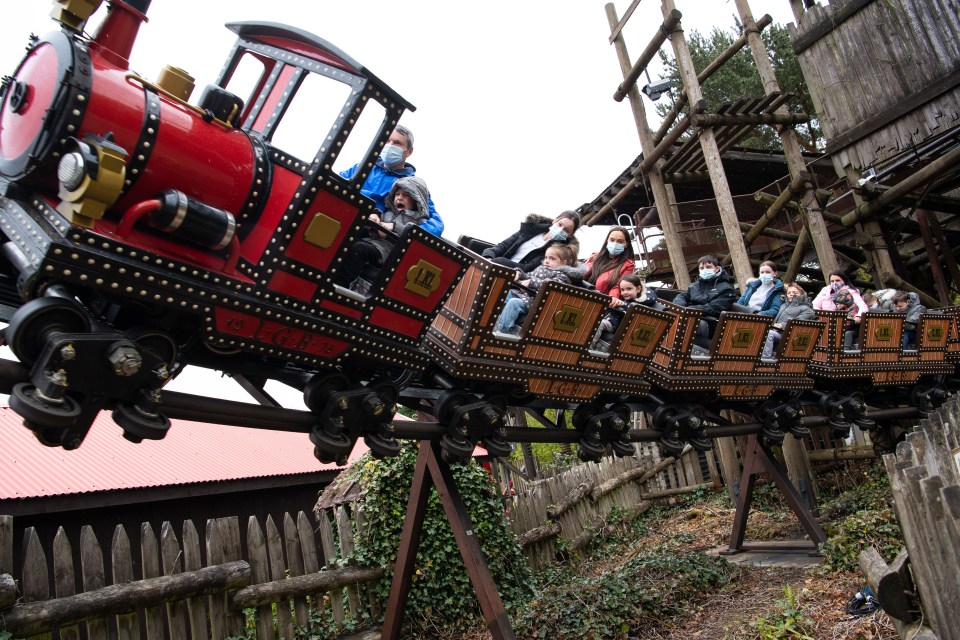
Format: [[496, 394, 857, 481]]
[[0, 512, 384, 640]]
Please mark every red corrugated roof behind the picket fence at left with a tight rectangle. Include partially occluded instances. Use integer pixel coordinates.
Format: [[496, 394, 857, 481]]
[[0, 407, 367, 500]]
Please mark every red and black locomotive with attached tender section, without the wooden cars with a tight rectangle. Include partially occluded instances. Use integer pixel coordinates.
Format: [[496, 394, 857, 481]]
[[0, 0, 471, 458]]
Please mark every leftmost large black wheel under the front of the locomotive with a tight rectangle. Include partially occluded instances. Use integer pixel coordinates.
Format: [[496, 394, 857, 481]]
[[7, 297, 90, 366]]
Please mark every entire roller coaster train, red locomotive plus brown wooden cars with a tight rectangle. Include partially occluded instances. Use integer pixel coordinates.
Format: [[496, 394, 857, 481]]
[[0, 0, 960, 460]]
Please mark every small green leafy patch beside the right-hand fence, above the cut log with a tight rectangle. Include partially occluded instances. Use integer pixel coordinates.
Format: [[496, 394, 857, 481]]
[[820, 508, 903, 571]]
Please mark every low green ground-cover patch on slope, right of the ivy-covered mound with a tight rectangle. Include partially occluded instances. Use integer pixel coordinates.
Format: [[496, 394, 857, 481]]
[[513, 546, 735, 640]]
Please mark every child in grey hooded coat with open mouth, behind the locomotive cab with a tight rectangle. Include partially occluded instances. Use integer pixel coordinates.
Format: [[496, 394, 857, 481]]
[[334, 176, 430, 294]]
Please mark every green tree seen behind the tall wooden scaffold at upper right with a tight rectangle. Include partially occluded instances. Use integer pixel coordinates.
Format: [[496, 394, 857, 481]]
[[657, 18, 822, 150]]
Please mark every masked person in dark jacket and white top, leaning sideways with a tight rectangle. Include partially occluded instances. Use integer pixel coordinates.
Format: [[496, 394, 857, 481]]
[[483, 211, 580, 272]]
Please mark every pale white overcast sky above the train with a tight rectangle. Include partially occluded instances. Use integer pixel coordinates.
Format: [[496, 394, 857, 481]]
[[0, 0, 793, 404]]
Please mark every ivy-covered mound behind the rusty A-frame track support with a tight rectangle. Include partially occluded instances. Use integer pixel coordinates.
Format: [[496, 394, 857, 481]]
[[349, 444, 532, 625]]
